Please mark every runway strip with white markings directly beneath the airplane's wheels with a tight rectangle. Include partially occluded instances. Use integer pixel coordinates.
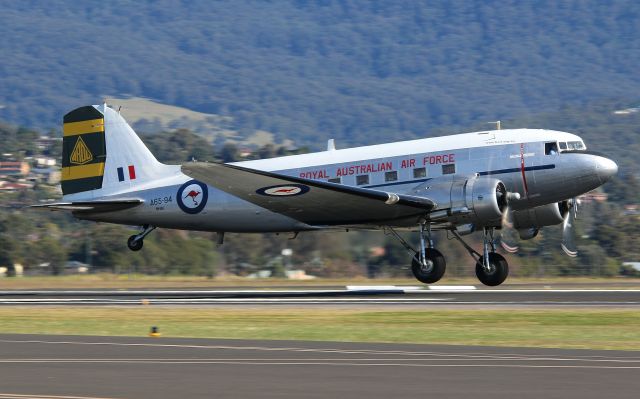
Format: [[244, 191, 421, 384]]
[[0, 286, 640, 308]]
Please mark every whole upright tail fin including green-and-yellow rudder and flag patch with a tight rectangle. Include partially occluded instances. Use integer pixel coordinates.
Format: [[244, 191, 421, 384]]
[[61, 104, 168, 200]]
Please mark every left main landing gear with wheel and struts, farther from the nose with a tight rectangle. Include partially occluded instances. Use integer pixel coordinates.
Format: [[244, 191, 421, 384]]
[[388, 223, 447, 284]]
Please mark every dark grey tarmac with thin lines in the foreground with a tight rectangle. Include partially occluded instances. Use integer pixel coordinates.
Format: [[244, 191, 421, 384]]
[[0, 335, 640, 399]]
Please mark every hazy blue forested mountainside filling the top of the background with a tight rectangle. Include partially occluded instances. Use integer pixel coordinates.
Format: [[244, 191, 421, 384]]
[[0, 0, 640, 148]]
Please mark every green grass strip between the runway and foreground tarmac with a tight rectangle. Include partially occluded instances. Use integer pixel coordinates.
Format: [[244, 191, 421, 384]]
[[0, 306, 640, 350]]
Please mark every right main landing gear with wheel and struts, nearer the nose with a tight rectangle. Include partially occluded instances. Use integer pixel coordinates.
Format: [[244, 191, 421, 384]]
[[452, 228, 509, 287]]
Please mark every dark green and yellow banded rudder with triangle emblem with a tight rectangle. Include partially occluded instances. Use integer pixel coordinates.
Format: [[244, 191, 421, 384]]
[[62, 106, 107, 195]]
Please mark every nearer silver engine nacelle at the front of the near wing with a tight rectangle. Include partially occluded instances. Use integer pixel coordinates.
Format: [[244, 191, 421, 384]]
[[412, 175, 507, 227]]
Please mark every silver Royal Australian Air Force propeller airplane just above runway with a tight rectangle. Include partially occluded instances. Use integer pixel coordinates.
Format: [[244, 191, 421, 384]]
[[34, 104, 618, 286]]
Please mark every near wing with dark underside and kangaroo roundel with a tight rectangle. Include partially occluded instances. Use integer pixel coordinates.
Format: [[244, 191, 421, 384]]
[[182, 162, 435, 225]]
